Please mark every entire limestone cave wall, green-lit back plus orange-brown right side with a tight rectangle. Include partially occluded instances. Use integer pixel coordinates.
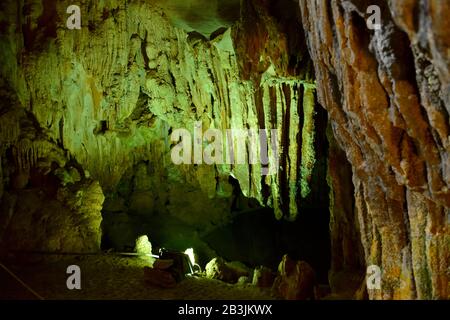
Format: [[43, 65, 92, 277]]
[[0, 0, 450, 299]]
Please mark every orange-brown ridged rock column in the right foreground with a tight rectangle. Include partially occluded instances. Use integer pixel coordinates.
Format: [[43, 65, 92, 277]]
[[300, 0, 450, 299]]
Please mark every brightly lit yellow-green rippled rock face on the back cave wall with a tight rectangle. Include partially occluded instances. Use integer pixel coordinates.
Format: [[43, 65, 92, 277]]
[[0, 0, 324, 224]]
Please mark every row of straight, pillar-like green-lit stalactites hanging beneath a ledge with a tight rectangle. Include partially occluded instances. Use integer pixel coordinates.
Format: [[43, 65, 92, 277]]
[[261, 80, 315, 220]]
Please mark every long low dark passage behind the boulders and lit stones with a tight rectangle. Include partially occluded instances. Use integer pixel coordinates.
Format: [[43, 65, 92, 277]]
[[102, 184, 330, 284]]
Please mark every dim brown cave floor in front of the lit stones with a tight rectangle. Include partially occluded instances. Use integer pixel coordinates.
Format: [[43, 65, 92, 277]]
[[0, 255, 273, 300]]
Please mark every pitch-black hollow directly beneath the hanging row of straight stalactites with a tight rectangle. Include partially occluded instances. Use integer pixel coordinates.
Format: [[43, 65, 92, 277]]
[[205, 207, 330, 284]]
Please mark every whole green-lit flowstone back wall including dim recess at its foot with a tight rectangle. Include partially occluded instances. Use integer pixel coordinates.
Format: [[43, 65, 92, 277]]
[[0, 0, 325, 258]]
